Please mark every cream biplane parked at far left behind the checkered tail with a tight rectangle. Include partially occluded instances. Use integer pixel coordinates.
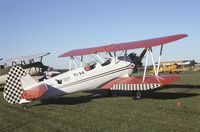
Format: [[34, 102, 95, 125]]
[[0, 52, 50, 85]]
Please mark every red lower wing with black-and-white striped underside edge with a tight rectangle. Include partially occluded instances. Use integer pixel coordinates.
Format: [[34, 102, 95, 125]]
[[102, 75, 180, 91]]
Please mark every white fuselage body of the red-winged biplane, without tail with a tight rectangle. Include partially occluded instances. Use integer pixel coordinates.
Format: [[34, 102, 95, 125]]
[[41, 58, 133, 99]]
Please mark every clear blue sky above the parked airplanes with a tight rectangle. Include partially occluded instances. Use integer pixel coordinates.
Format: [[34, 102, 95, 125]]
[[0, 0, 200, 68]]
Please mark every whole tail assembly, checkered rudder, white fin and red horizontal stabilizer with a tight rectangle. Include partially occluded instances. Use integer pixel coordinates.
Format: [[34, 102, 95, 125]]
[[3, 66, 48, 104]]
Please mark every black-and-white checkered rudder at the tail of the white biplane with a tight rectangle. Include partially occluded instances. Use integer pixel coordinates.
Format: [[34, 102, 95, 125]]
[[3, 66, 26, 104]]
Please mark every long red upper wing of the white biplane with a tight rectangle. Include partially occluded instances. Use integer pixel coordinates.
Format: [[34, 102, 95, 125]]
[[59, 34, 188, 57]]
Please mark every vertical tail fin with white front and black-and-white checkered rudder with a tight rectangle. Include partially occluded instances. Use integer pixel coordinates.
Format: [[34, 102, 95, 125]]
[[3, 66, 36, 104]]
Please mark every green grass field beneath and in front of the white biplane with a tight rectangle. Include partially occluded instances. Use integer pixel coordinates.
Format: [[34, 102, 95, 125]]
[[0, 73, 200, 132]]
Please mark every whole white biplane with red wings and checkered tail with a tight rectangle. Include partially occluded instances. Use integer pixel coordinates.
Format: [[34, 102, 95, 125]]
[[3, 34, 187, 104]]
